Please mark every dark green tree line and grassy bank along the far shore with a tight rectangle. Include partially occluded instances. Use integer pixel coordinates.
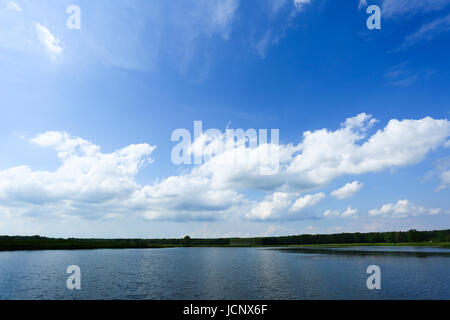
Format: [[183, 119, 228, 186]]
[[0, 229, 450, 251]]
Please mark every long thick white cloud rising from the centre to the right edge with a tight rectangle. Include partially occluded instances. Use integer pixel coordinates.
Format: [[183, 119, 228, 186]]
[[191, 114, 450, 192]]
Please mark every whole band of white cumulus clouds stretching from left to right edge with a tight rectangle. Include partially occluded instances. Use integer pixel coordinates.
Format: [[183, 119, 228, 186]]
[[0, 114, 450, 221]]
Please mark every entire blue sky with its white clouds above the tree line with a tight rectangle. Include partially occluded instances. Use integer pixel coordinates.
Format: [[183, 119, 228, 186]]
[[0, 0, 450, 237]]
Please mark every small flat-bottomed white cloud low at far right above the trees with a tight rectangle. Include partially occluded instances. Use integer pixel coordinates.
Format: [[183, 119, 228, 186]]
[[369, 200, 442, 218]]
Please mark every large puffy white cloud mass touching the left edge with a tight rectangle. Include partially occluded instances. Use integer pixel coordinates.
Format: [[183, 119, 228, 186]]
[[0, 132, 155, 217]]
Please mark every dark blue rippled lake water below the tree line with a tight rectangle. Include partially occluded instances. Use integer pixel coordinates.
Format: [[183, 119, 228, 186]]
[[0, 247, 450, 299]]
